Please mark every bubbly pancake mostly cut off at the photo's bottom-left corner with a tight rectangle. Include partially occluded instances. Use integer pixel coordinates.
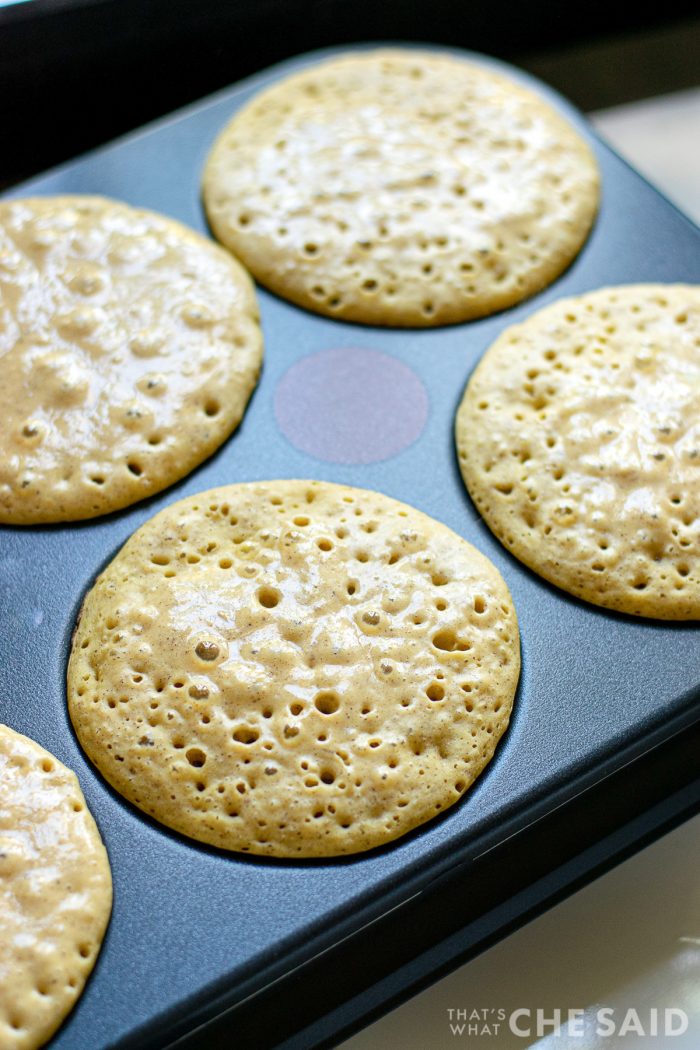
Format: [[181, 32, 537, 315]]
[[0, 725, 112, 1050]]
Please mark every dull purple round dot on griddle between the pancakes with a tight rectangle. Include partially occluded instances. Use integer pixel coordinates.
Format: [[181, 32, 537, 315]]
[[275, 348, 428, 463]]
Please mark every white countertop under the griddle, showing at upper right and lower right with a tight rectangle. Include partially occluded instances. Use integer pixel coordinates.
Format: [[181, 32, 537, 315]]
[[342, 88, 700, 1050]]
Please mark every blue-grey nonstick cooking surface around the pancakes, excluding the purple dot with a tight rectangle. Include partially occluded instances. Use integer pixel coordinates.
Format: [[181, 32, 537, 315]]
[[0, 53, 700, 1050]]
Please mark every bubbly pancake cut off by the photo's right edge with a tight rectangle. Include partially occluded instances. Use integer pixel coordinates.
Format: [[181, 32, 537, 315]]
[[457, 285, 700, 620]]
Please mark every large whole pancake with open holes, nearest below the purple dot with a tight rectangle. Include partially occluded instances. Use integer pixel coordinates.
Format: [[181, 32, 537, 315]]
[[68, 481, 519, 857]]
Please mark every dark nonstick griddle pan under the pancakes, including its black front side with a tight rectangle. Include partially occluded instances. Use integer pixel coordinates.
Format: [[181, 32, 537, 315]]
[[0, 45, 700, 1050]]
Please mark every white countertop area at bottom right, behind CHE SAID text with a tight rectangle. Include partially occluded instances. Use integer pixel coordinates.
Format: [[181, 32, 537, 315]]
[[342, 816, 700, 1050]]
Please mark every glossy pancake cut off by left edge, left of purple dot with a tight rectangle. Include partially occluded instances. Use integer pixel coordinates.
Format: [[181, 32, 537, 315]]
[[0, 196, 262, 525]]
